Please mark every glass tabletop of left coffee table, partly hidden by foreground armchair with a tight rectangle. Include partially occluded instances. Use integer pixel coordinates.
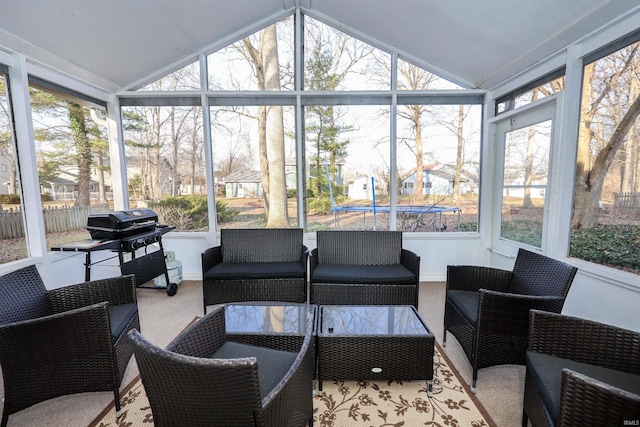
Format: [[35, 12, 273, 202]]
[[224, 304, 315, 335]]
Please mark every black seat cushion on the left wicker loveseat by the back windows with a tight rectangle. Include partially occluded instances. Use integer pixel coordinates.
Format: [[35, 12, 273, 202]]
[[203, 262, 305, 280]]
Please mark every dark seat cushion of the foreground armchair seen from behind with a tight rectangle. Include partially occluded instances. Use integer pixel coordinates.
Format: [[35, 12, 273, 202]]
[[211, 341, 298, 399]]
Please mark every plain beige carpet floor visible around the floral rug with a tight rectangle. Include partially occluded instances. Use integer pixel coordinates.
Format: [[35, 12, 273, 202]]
[[0, 281, 524, 427]]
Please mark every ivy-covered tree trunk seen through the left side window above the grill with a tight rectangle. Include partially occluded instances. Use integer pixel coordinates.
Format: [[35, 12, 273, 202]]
[[67, 102, 93, 206]]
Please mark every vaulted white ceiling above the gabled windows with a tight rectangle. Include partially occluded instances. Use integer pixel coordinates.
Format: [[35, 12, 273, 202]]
[[0, 0, 640, 92]]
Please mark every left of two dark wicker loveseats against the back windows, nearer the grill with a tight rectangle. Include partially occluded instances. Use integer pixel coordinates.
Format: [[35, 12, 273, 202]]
[[202, 228, 309, 314]]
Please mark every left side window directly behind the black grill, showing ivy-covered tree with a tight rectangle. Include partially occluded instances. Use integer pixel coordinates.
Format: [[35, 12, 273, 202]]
[[30, 80, 113, 249]]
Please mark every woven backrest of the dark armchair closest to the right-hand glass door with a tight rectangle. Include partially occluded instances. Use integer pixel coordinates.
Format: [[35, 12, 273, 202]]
[[508, 249, 576, 296]]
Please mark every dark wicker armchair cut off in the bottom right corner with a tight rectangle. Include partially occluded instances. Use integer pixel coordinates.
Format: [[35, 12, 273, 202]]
[[522, 310, 640, 427]]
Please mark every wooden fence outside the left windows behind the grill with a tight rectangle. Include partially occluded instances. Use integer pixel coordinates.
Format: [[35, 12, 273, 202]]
[[0, 205, 109, 240]]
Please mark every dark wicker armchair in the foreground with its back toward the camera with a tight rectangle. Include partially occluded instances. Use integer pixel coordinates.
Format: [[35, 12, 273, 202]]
[[130, 306, 315, 427]]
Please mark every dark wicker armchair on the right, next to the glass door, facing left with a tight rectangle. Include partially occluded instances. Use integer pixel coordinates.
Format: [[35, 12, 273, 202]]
[[443, 249, 577, 393]]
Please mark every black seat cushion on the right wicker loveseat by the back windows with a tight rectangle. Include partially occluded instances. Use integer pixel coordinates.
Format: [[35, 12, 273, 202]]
[[311, 264, 416, 284]]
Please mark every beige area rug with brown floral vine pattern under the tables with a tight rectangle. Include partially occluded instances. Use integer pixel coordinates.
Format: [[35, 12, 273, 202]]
[[91, 344, 495, 427]]
